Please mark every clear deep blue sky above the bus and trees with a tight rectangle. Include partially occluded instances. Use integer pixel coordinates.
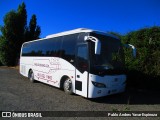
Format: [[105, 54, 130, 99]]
[[0, 0, 160, 38]]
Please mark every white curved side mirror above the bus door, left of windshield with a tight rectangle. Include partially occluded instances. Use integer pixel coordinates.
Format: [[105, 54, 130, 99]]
[[84, 36, 101, 55]]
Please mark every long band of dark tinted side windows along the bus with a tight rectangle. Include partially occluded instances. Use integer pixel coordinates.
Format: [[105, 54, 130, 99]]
[[22, 34, 78, 60]]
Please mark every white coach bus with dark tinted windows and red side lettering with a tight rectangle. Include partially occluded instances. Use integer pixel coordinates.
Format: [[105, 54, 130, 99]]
[[20, 28, 134, 98]]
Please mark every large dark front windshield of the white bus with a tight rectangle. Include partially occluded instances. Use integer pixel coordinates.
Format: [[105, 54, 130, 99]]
[[90, 33, 124, 75]]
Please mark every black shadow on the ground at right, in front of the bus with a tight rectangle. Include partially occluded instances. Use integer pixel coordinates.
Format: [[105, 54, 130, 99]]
[[90, 89, 160, 105]]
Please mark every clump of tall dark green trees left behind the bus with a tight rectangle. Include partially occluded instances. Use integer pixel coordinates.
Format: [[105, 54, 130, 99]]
[[0, 2, 41, 66]]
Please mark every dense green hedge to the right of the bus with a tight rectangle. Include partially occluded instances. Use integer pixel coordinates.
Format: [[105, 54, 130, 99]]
[[121, 26, 160, 89]]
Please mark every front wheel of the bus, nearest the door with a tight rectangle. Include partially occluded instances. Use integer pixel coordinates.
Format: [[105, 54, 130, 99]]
[[63, 78, 73, 95]]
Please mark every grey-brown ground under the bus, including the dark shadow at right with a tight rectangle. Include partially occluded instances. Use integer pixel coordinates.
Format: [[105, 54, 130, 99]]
[[0, 67, 160, 119]]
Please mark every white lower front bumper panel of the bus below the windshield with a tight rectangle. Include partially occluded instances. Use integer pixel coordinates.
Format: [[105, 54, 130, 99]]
[[88, 75, 126, 98]]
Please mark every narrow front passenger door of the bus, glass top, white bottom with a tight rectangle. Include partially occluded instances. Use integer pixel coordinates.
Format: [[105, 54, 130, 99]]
[[75, 44, 89, 97]]
